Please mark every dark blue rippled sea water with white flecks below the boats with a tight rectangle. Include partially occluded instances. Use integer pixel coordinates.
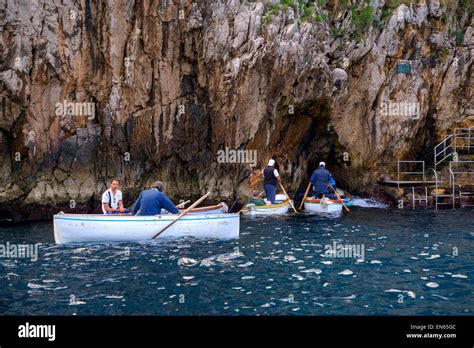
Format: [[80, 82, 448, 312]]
[[0, 207, 474, 315]]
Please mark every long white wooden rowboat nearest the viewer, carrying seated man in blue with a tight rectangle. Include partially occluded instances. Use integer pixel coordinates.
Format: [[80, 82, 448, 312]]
[[53, 213, 240, 244]]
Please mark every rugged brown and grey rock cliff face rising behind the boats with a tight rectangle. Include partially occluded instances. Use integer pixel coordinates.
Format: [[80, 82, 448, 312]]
[[0, 0, 474, 218]]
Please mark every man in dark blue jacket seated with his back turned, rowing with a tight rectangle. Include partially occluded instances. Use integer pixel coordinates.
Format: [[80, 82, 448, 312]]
[[132, 181, 179, 215]]
